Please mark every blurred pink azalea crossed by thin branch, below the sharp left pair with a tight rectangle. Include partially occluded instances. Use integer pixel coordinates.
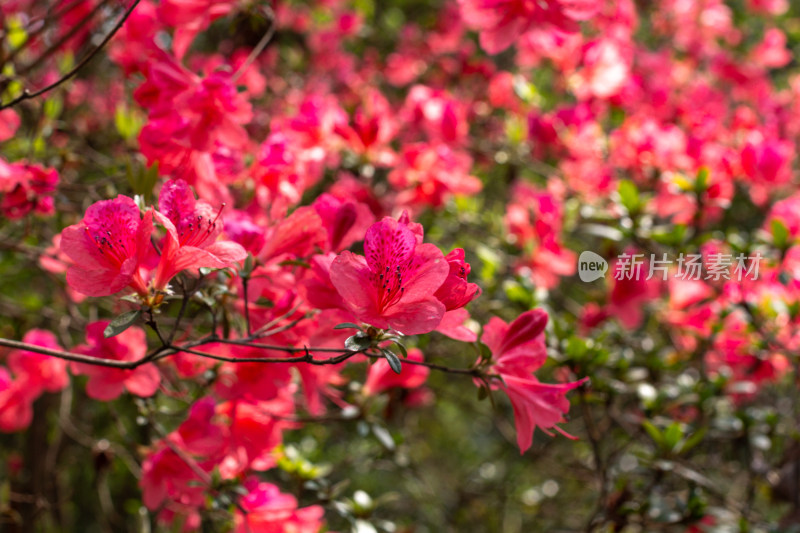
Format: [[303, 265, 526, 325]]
[[72, 320, 161, 401]]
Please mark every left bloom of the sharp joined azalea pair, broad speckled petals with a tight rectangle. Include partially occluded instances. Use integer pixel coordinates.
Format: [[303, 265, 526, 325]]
[[61, 195, 153, 297]]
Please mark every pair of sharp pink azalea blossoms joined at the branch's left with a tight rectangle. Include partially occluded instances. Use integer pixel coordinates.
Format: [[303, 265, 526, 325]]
[[60, 180, 247, 306]]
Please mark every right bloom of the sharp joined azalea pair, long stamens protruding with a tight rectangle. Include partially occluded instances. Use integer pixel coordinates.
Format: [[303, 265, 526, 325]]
[[155, 180, 247, 289]]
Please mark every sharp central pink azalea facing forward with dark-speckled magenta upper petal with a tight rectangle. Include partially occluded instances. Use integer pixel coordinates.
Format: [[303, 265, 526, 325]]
[[330, 217, 450, 335]]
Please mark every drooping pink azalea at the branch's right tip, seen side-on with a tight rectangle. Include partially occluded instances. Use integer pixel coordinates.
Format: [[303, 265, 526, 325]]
[[481, 309, 588, 453]]
